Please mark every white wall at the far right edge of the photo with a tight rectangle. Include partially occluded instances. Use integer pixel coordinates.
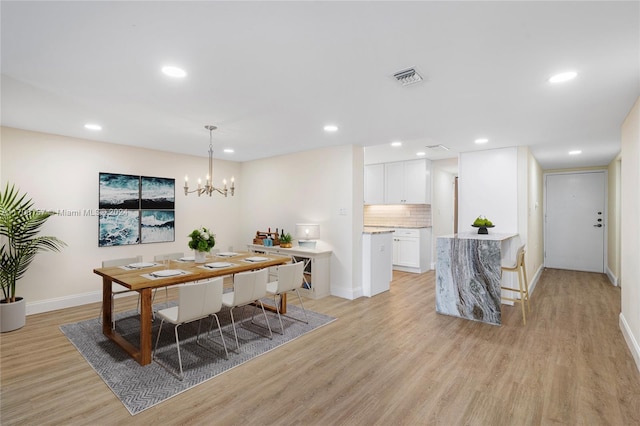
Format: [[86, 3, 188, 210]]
[[620, 98, 640, 370]]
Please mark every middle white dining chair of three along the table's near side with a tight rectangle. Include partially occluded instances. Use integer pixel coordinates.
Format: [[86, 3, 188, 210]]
[[222, 268, 273, 351]]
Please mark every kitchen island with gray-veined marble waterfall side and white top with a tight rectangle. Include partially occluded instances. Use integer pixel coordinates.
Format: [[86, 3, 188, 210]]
[[436, 233, 520, 325]]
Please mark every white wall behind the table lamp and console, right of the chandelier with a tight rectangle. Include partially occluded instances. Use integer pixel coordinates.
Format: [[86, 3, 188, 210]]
[[241, 146, 364, 299]]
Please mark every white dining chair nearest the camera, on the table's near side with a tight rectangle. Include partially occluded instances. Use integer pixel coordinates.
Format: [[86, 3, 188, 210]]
[[153, 278, 229, 380]]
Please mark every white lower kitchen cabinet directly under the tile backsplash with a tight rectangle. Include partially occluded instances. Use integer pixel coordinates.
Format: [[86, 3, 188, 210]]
[[393, 228, 431, 273]]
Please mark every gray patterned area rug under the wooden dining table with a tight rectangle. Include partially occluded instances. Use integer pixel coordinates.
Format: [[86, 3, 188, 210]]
[[60, 301, 335, 415]]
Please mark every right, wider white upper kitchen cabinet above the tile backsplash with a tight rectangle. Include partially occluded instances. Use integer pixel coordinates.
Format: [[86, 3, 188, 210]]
[[384, 159, 431, 204]]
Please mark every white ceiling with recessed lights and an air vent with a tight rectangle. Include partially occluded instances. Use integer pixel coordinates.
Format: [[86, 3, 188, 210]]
[[0, 1, 640, 169]]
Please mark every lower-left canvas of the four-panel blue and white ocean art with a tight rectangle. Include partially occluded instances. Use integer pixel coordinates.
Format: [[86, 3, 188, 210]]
[[98, 209, 140, 247]]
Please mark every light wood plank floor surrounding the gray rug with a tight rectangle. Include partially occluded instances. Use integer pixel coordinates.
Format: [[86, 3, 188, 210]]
[[0, 270, 640, 425]]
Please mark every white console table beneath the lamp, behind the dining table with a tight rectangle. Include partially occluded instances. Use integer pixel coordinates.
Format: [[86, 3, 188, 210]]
[[247, 244, 331, 299]]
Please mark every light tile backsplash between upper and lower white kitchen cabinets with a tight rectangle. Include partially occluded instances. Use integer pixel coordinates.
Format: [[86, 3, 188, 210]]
[[364, 204, 431, 227]]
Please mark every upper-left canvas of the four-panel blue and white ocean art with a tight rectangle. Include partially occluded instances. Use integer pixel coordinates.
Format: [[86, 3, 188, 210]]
[[98, 173, 140, 209]]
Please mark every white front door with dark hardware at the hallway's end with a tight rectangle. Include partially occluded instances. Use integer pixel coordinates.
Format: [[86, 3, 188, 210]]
[[544, 171, 606, 273]]
